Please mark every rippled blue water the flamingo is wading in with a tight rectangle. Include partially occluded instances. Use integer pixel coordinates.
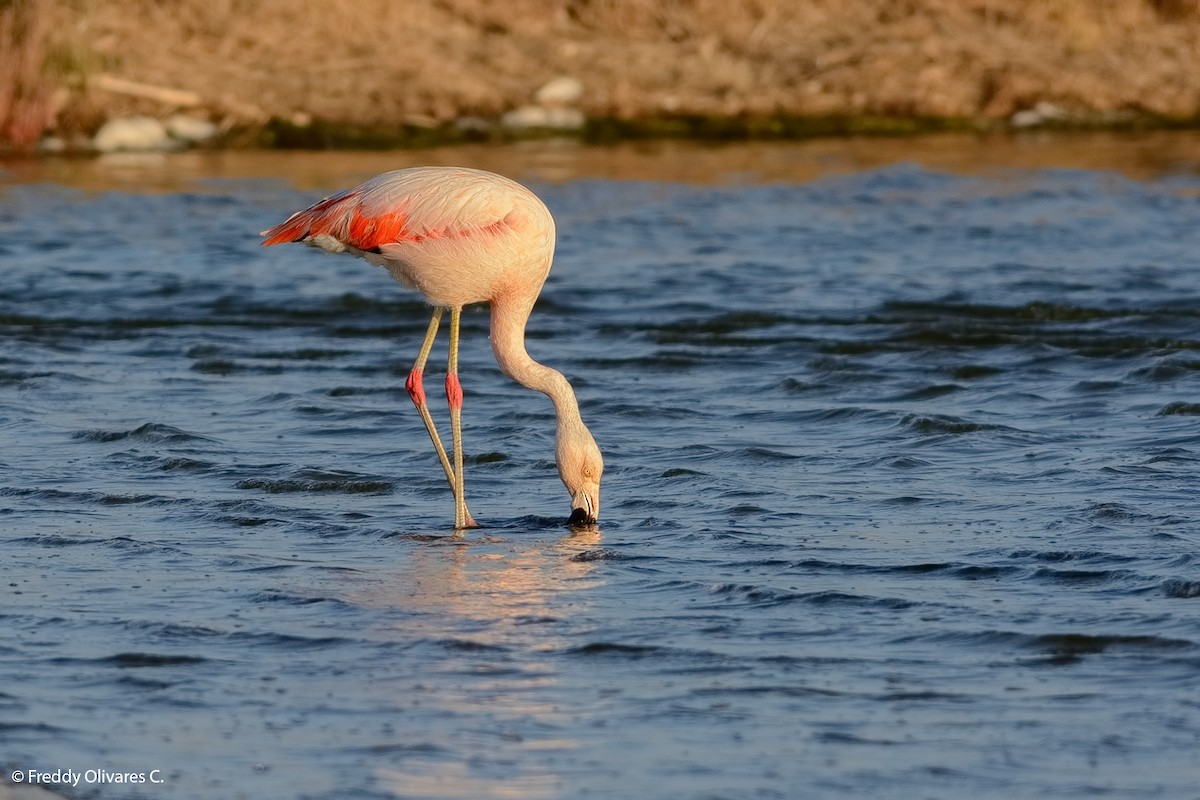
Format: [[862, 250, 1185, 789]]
[[0, 134, 1200, 799]]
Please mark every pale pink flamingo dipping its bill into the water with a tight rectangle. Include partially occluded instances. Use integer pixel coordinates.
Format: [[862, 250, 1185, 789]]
[[262, 167, 604, 534]]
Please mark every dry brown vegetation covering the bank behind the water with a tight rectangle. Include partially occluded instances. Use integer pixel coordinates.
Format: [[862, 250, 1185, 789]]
[[7, 0, 1200, 149]]
